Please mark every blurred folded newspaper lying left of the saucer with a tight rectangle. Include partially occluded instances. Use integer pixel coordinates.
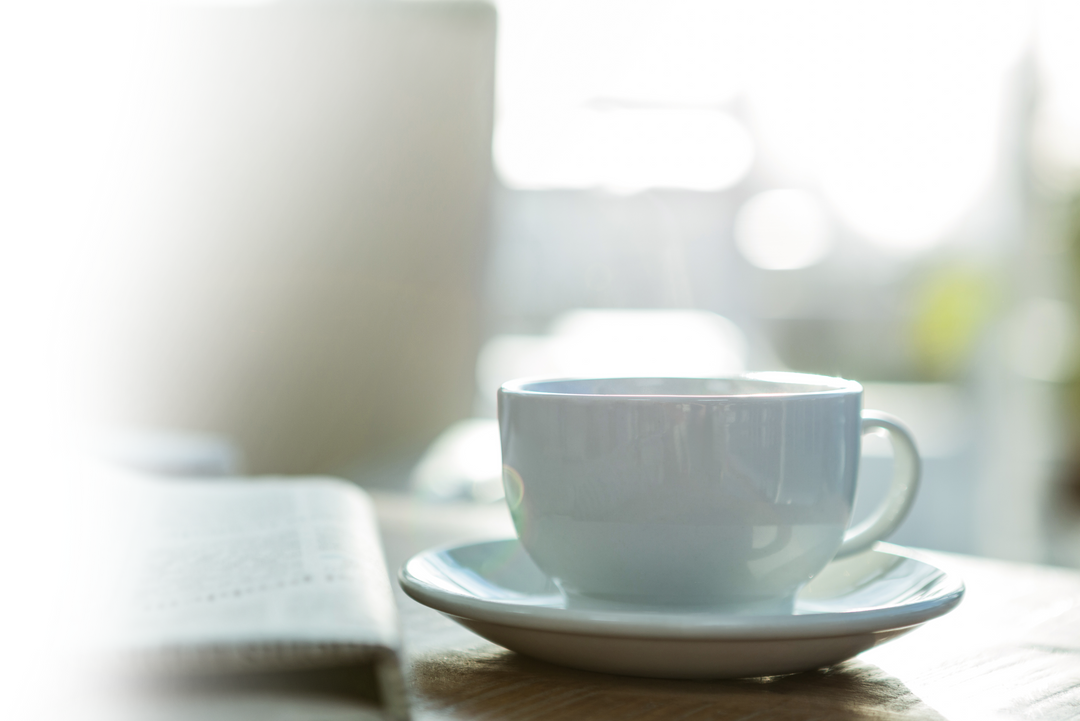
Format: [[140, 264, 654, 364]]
[[46, 455, 407, 718]]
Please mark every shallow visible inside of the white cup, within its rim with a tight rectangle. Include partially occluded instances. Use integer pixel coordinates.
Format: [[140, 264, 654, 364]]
[[503, 373, 862, 397]]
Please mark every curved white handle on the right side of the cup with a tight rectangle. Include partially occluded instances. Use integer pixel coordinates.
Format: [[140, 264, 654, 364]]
[[834, 410, 922, 558]]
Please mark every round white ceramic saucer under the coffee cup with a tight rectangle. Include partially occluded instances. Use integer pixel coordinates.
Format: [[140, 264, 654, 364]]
[[399, 540, 963, 679]]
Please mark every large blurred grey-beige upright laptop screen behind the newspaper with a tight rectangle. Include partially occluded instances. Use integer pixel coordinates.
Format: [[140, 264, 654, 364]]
[[60, 1, 495, 473]]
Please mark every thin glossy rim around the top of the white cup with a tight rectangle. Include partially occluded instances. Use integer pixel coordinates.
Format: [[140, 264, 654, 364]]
[[499, 371, 863, 400]]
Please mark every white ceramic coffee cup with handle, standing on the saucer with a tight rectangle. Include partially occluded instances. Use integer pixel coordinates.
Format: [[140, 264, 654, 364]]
[[499, 373, 920, 613]]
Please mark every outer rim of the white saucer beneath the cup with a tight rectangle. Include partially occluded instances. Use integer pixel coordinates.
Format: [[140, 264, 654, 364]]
[[397, 538, 966, 641]]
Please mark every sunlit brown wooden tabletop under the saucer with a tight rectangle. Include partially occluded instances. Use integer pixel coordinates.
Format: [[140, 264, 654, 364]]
[[374, 493, 1080, 721]]
